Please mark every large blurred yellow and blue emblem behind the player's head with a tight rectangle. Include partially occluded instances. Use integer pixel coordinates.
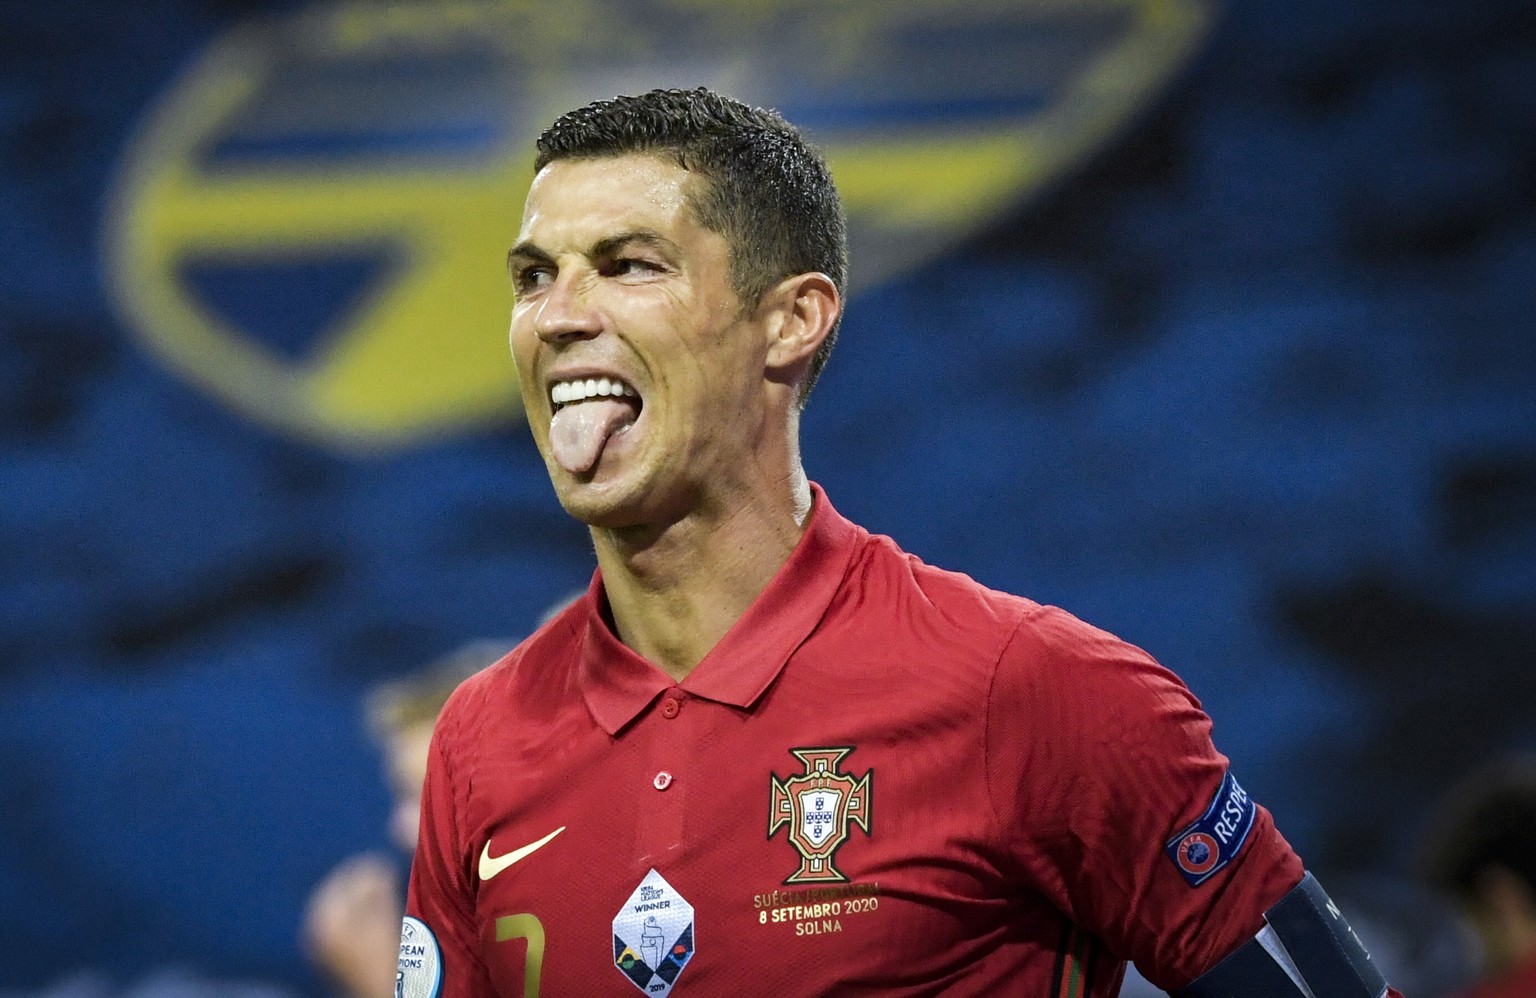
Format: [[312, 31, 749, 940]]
[[106, 0, 1210, 448]]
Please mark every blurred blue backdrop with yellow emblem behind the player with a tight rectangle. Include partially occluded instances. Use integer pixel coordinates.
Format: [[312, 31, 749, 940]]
[[0, 0, 1536, 995]]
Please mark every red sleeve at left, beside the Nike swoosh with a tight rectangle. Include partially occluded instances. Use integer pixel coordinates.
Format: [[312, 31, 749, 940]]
[[406, 700, 495, 998]]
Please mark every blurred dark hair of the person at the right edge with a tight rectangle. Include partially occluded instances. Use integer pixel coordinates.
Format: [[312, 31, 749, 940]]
[[1422, 755, 1536, 900]]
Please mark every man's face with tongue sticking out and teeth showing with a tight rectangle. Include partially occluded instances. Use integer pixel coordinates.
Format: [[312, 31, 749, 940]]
[[508, 155, 768, 528]]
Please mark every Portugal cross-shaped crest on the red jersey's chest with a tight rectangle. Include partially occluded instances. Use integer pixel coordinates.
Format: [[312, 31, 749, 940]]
[[768, 746, 874, 884]]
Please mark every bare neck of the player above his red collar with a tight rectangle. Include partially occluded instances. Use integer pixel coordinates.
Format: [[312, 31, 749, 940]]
[[591, 462, 811, 682]]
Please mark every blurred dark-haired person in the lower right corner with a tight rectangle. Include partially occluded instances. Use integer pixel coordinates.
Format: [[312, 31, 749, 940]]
[[1424, 755, 1536, 998]]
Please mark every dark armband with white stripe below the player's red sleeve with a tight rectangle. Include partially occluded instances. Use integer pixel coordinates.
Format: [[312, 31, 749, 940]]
[[1174, 874, 1387, 998]]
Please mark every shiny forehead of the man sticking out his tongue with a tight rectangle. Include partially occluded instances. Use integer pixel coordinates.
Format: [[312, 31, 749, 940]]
[[519, 155, 697, 252]]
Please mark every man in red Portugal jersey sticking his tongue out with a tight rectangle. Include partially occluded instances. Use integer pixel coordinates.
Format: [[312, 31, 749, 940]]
[[396, 91, 1387, 998]]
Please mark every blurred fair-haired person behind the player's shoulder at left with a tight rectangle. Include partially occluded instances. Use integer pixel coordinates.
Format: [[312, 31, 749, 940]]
[[301, 639, 516, 998]]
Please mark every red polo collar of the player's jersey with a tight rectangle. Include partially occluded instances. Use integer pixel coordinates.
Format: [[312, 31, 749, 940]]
[[578, 482, 866, 735]]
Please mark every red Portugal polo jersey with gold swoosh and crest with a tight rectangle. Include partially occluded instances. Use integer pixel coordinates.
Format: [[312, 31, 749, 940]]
[[407, 488, 1303, 998]]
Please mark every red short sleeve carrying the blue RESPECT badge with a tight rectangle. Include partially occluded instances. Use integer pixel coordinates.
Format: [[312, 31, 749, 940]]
[[986, 606, 1303, 990]]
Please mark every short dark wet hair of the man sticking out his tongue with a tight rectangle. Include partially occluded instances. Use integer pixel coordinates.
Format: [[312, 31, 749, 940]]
[[533, 88, 848, 401]]
